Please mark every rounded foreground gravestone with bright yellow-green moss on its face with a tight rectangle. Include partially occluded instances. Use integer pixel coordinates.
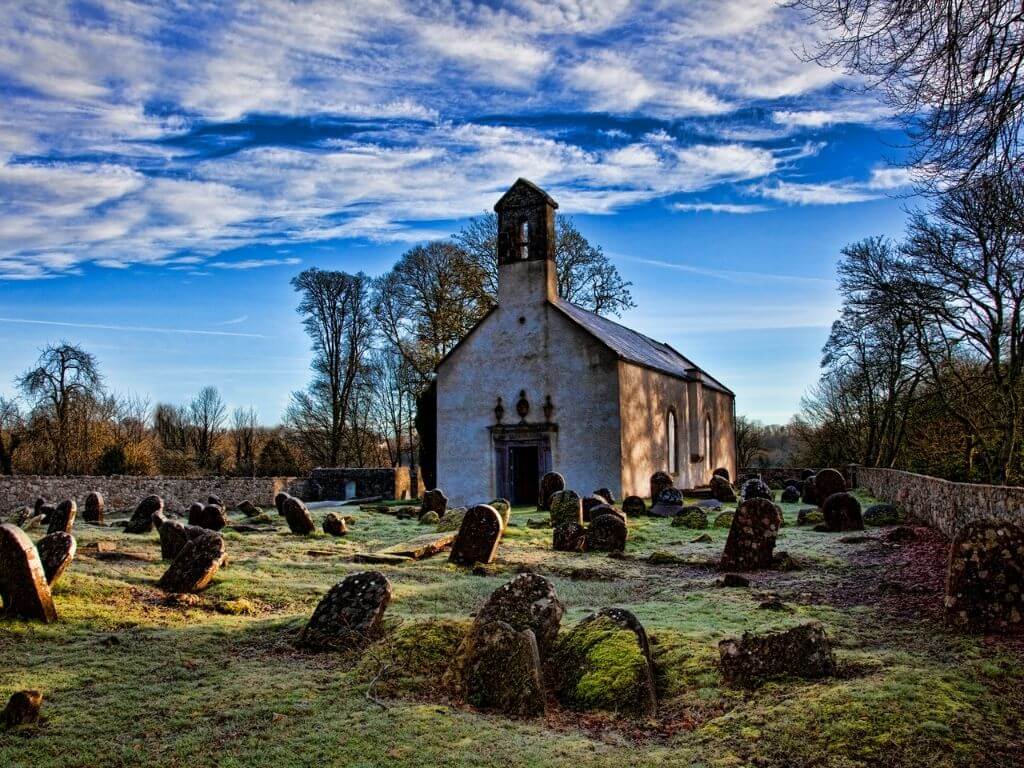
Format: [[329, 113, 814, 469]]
[[548, 608, 657, 717]]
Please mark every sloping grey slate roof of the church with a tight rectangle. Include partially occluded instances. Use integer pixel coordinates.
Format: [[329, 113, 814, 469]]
[[551, 298, 732, 394]]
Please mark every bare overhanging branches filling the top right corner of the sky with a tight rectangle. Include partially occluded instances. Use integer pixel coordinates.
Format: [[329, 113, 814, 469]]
[[791, 0, 1024, 186]]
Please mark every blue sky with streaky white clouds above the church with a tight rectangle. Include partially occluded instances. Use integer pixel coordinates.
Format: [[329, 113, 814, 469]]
[[0, 0, 913, 424]]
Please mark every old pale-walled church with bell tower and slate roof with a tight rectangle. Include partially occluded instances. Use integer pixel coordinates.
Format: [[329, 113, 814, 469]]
[[436, 179, 736, 505]]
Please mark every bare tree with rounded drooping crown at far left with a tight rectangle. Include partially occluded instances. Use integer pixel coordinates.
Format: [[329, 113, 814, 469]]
[[17, 342, 102, 475]]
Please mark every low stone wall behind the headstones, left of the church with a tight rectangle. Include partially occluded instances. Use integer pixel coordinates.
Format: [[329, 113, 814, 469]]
[[0, 475, 303, 513]]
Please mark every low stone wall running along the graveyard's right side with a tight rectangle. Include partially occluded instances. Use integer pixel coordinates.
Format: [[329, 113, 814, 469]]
[[857, 467, 1024, 539]]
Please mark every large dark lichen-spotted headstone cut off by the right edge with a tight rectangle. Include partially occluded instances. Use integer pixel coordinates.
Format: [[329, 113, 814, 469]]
[[945, 519, 1024, 632]]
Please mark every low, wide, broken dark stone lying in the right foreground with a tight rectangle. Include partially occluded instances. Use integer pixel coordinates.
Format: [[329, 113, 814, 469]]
[[718, 622, 836, 686]]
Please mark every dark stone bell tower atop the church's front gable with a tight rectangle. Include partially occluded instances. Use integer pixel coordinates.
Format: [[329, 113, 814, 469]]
[[495, 178, 558, 307]]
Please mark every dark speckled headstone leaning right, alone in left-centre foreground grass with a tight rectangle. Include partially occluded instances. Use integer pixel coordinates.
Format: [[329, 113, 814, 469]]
[[299, 570, 391, 650]]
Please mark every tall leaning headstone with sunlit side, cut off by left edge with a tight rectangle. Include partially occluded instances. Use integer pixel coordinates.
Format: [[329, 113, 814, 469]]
[[0, 523, 57, 624]]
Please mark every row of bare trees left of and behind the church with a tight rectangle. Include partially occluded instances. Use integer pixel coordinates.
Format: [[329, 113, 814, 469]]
[[0, 213, 634, 476]]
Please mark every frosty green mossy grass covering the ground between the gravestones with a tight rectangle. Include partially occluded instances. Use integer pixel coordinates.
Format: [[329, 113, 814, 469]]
[[0, 498, 1024, 768]]
